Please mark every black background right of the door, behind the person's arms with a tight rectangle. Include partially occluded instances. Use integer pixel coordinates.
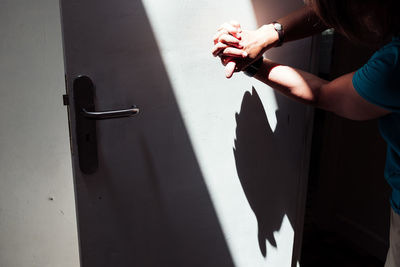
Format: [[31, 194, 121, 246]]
[[302, 33, 390, 267]]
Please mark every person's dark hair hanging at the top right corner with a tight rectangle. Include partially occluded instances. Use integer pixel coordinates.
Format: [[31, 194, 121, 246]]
[[305, 0, 400, 42]]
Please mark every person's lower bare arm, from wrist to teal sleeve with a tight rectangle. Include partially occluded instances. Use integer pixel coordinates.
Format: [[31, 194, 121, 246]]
[[255, 59, 390, 120]]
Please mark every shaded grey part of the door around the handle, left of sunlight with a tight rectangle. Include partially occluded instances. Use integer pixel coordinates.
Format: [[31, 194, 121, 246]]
[[62, 0, 233, 267]]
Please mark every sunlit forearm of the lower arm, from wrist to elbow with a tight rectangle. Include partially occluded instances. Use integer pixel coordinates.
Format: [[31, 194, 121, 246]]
[[254, 59, 328, 107]]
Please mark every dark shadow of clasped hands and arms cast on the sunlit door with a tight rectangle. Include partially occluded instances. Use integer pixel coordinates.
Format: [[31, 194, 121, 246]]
[[233, 88, 293, 257]]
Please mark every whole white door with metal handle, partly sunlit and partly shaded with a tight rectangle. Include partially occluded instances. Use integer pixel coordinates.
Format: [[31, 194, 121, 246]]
[[61, 0, 311, 267]]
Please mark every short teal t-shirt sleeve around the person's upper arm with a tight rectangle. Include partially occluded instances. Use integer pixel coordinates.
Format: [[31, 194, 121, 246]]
[[353, 47, 400, 112]]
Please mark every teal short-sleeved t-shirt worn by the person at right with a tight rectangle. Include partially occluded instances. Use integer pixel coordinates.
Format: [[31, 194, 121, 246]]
[[353, 37, 400, 214]]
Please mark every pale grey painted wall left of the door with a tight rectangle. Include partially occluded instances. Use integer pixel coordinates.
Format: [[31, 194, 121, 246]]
[[0, 0, 79, 267]]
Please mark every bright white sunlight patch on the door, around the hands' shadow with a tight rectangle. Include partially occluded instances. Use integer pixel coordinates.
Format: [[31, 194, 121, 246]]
[[142, 0, 294, 267]]
